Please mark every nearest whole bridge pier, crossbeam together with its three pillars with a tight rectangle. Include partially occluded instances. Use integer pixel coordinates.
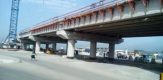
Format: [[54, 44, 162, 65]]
[[56, 30, 123, 59]]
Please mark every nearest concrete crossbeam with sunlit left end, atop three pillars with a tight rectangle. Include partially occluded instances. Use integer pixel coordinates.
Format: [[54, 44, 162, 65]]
[[56, 30, 123, 44]]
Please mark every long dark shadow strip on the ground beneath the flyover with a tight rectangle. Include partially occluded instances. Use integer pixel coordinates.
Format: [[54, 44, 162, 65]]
[[76, 55, 163, 74]]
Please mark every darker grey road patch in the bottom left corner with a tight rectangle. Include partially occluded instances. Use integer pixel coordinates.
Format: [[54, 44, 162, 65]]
[[0, 66, 46, 80]]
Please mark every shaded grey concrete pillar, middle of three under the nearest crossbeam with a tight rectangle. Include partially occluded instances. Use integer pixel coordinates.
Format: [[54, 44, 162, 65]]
[[90, 41, 97, 59]]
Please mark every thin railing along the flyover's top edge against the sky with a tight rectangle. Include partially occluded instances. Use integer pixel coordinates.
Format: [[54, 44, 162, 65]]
[[20, 0, 126, 34]]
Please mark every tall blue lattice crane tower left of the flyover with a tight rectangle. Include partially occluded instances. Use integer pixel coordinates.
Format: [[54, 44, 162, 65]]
[[3, 0, 20, 48]]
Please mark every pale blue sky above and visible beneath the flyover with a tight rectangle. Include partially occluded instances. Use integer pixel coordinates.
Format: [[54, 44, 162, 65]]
[[0, 0, 163, 51]]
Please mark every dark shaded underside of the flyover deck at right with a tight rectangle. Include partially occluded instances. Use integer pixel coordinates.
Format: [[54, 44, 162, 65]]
[[71, 14, 163, 37]]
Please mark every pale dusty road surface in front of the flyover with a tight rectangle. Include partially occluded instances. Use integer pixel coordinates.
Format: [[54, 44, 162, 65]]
[[0, 50, 159, 80]]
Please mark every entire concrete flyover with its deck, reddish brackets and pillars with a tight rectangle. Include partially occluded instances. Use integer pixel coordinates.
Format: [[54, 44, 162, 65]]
[[19, 0, 163, 59]]
